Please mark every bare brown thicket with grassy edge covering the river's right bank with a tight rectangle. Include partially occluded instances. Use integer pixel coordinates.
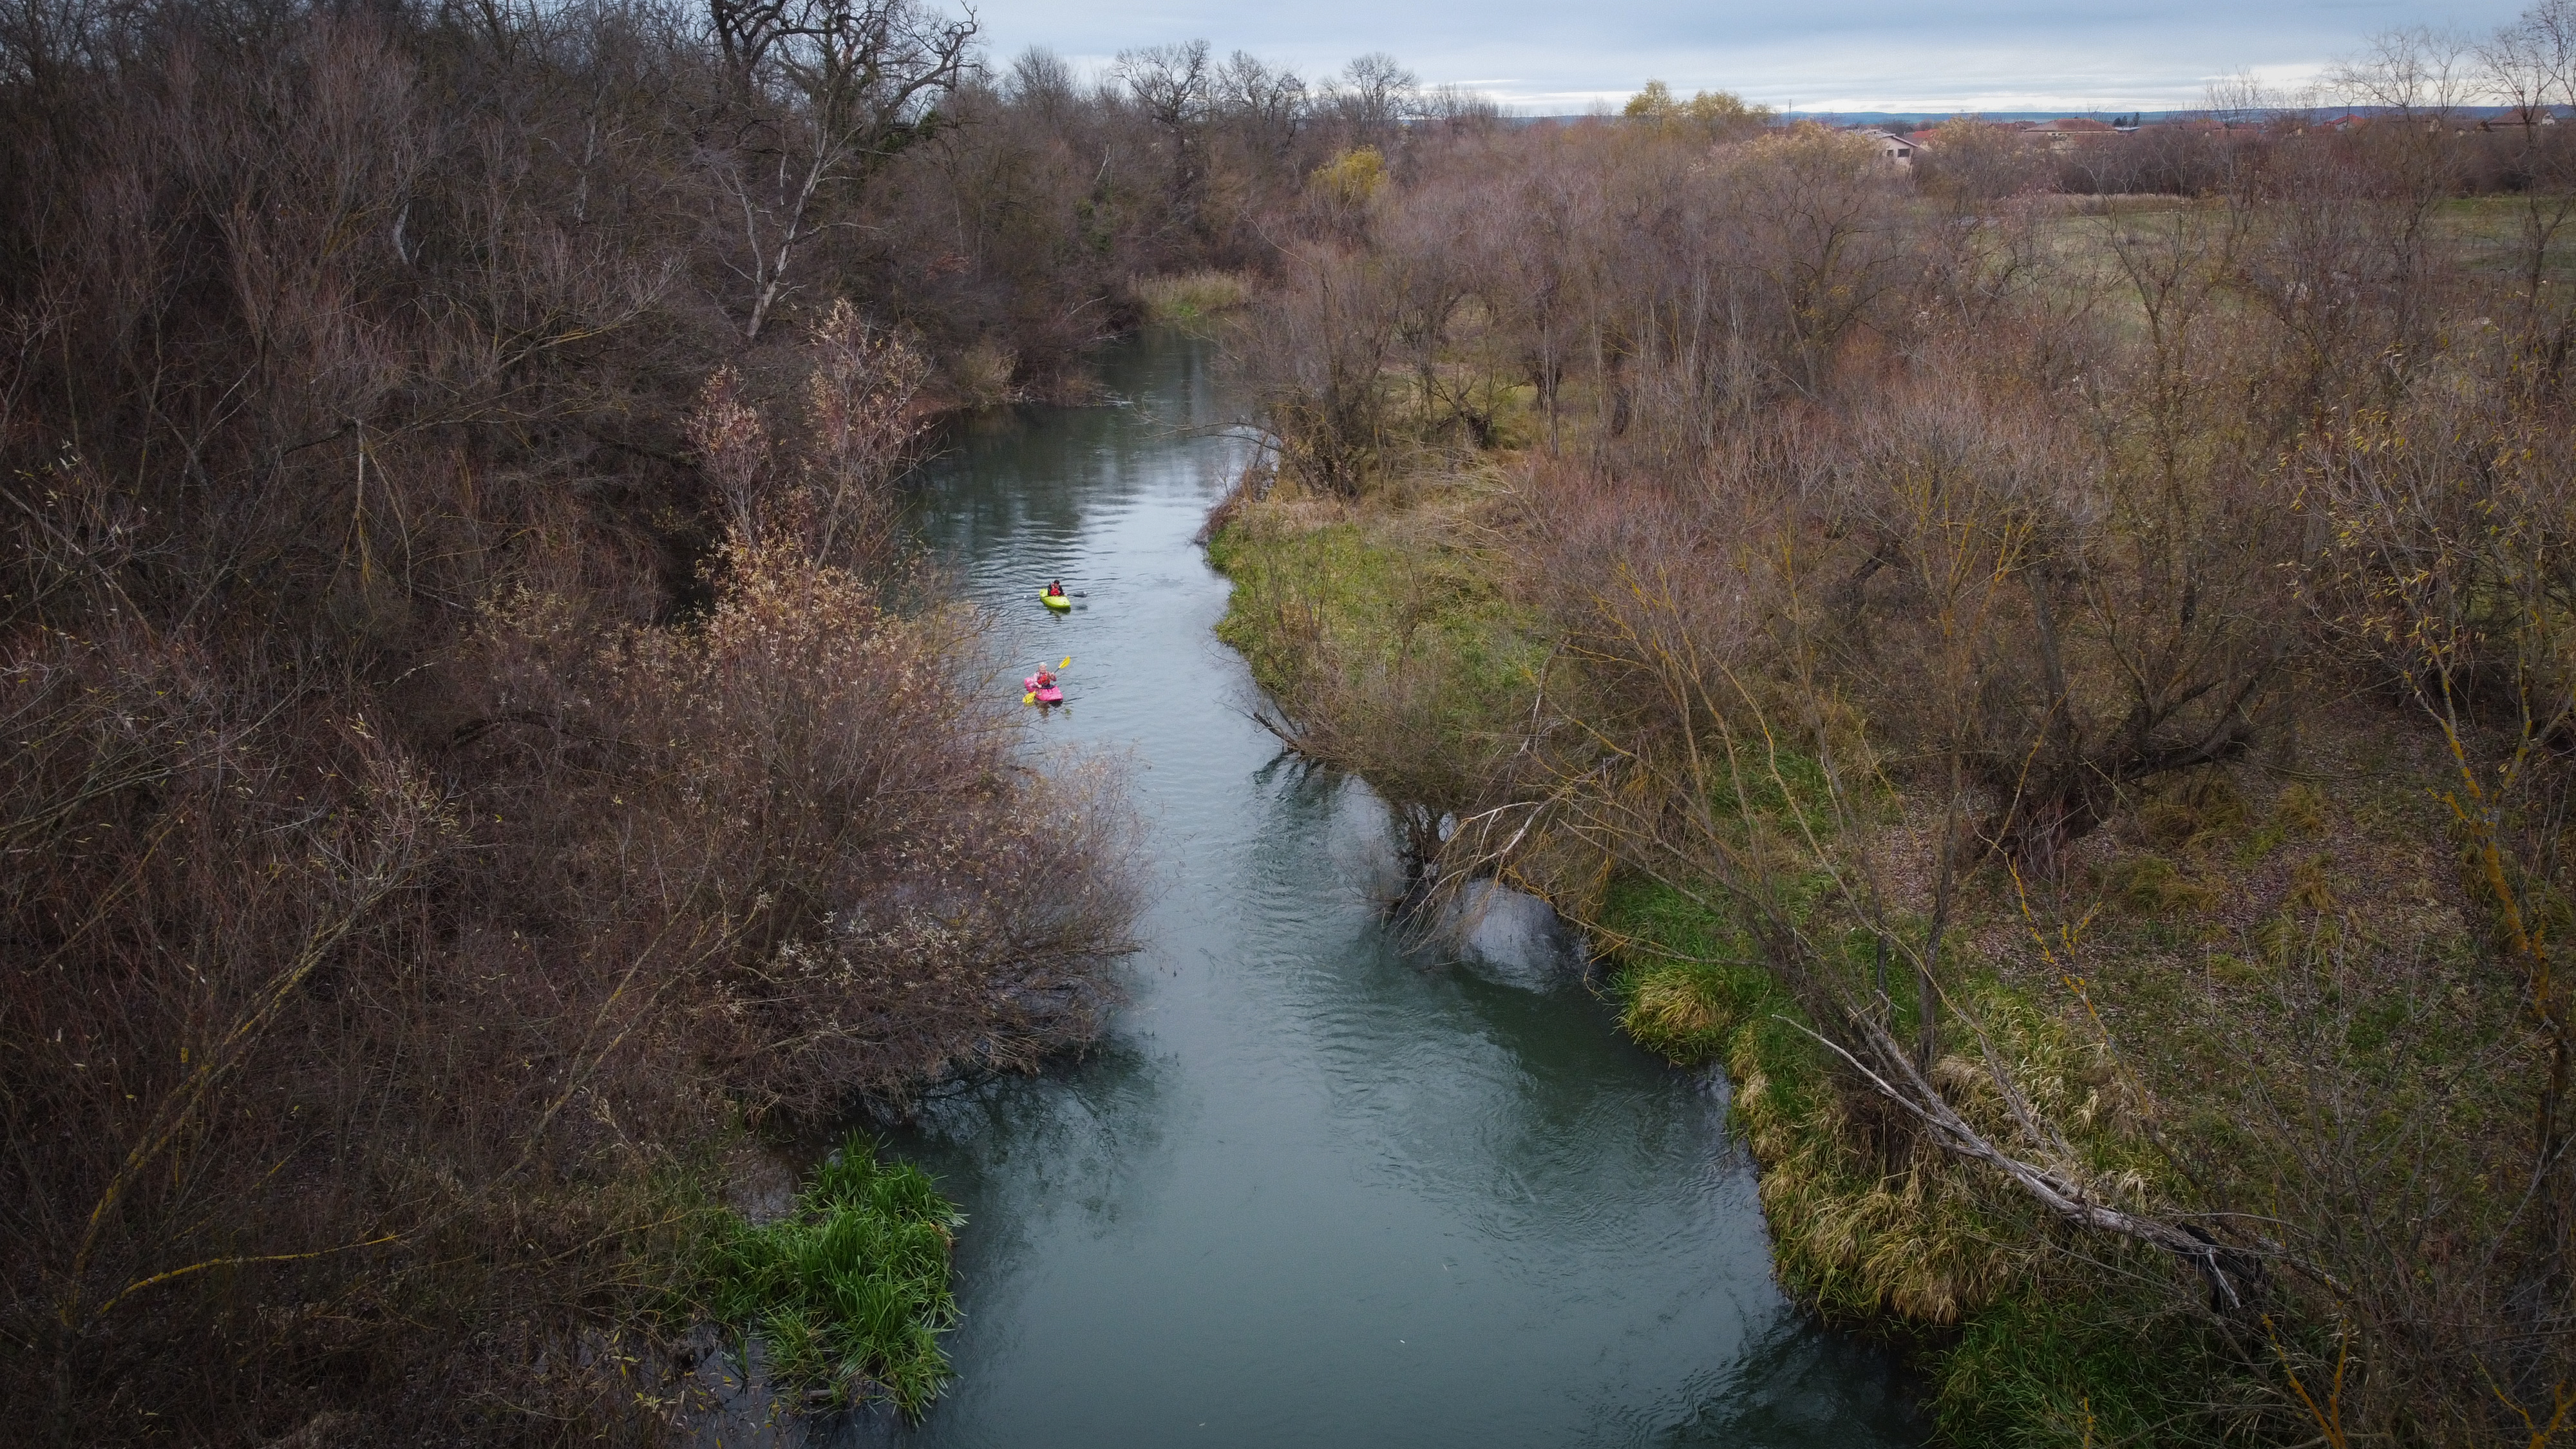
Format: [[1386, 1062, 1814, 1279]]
[[1218, 5, 2576, 1446]]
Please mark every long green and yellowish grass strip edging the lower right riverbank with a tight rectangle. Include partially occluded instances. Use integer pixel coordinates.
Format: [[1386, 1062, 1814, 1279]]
[[1602, 876, 2241, 1446]]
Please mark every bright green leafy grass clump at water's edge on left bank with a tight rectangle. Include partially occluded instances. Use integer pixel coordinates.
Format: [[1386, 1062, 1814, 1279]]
[[714, 1135, 966, 1418]]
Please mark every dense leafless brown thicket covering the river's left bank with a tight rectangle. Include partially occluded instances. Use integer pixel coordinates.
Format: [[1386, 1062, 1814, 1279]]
[[0, 0, 1473, 1444]]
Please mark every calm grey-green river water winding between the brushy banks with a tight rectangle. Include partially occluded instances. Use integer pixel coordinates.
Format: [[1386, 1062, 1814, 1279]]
[[829, 335, 1922, 1449]]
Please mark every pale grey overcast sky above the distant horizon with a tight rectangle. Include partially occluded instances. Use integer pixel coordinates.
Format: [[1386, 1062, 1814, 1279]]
[[976, 0, 2527, 113]]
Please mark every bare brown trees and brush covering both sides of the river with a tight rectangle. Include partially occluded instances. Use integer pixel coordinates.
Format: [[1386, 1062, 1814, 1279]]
[[20, 0, 2576, 1444]]
